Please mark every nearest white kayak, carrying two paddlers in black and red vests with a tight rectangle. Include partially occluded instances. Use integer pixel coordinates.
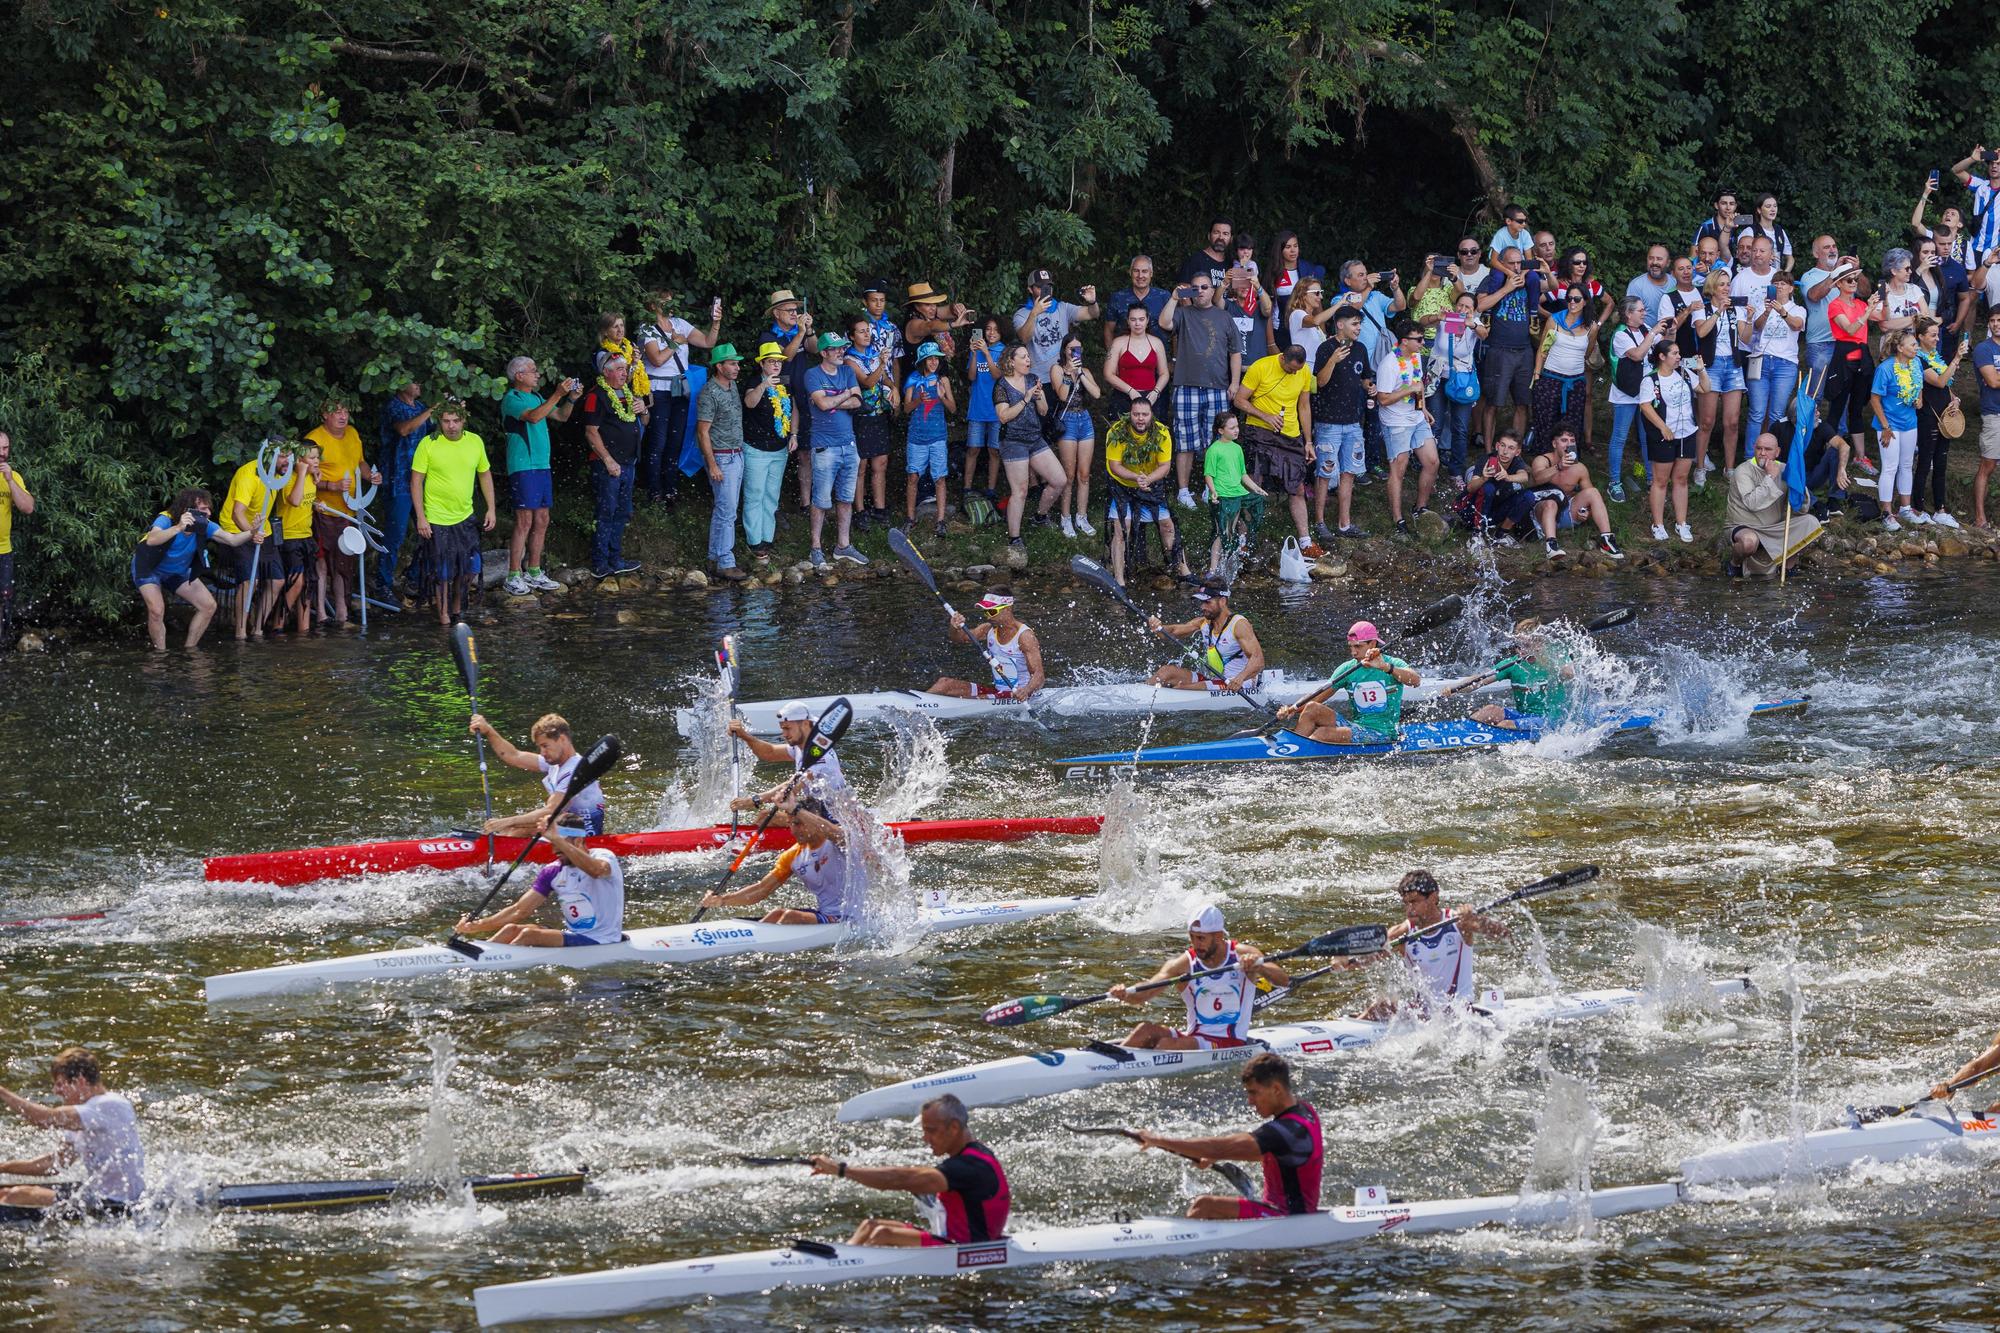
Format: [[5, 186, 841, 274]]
[[472, 1181, 1682, 1327]]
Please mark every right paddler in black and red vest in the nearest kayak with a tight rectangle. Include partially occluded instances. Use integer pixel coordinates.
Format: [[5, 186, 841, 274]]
[[1138, 1051, 1326, 1221]]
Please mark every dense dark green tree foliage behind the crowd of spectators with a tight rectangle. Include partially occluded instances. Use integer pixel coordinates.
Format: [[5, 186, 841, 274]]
[[0, 0, 2000, 624]]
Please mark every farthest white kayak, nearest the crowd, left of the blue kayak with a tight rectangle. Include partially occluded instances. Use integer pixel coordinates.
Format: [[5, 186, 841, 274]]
[[674, 667, 1512, 739]]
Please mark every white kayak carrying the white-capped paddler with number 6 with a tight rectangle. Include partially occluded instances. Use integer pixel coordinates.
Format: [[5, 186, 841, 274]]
[[836, 977, 1750, 1121]]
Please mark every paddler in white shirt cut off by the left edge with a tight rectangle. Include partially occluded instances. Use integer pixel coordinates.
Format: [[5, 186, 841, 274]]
[[0, 1047, 146, 1213]]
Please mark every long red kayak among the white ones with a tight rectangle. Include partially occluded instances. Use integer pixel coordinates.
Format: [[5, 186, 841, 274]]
[[202, 815, 1104, 885]]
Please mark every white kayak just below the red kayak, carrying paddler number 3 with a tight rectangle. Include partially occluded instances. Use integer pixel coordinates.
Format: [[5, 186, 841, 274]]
[[206, 895, 1096, 1003]]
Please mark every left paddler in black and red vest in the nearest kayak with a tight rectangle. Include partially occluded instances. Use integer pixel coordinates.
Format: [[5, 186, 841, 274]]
[[812, 1093, 1010, 1245]]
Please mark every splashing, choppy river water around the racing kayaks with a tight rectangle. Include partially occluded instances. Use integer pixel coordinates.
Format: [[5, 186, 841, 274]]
[[0, 564, 2000, 1329]]
